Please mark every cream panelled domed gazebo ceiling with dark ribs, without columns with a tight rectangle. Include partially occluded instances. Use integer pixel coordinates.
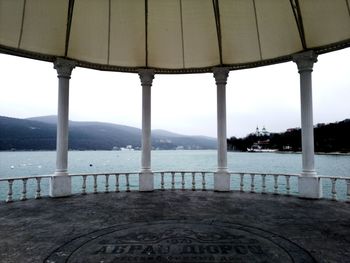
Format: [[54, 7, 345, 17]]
[[0, 0, 350, 73]]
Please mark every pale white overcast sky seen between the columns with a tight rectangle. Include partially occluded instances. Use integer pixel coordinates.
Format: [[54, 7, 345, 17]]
[[0, 48, 350, 137]]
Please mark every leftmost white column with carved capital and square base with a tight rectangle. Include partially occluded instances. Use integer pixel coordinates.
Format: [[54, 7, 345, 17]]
[[50, 58, 75, 197]]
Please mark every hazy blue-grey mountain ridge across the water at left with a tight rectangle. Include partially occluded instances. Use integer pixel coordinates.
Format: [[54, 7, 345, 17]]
[[0, 116, 216, 151]]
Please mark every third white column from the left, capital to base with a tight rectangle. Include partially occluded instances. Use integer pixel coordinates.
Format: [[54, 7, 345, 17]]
[[213, 68, 230, 191]]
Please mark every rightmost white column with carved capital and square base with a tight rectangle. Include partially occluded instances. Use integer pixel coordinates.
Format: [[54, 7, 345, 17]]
[[293, 51, 322, 198]]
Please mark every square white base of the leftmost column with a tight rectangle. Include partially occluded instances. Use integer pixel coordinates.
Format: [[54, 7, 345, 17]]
[[50, 172, 72, 197]]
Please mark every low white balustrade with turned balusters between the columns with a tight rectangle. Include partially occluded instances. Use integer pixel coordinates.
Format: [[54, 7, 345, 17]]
[[0, 171, 350, 202]]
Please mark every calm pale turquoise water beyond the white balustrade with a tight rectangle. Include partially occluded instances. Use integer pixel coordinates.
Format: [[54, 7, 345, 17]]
[[0, 150, 350, 200]]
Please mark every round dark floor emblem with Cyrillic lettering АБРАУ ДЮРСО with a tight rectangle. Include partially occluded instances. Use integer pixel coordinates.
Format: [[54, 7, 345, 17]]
[[45, 221, 315, 263]]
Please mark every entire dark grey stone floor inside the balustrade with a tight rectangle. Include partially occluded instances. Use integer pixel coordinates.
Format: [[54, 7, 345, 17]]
[[0, 190, 350, 263]]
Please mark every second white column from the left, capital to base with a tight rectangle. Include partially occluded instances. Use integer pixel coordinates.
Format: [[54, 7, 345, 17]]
[[139, 69, 154, 191]]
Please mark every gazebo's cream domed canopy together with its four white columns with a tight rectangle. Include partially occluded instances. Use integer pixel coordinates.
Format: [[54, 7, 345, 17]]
[[0, 0, 350, 198]]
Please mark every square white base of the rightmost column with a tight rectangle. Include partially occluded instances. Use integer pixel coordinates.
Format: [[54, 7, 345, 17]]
[[298, 174, 322, 199]]
